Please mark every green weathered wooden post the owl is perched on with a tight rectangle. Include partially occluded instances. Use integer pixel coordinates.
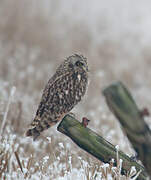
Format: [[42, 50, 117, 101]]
[[57, 115, 147, 180]]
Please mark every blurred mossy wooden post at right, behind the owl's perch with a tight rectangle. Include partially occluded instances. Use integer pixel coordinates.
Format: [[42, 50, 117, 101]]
[[103, 82, 151, 176]]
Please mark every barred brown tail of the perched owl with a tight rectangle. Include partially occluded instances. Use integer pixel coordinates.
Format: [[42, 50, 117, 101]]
[[26, 121, 50, 141]]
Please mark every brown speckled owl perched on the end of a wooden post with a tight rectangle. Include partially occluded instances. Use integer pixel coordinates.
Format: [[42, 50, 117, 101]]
[[26, 54, 88, 140]]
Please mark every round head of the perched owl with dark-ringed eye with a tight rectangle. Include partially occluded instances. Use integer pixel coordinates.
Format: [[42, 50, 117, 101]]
[[66, 54, 88, 72]]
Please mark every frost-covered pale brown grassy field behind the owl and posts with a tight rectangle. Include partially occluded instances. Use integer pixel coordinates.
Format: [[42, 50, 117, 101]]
[[0, 0, 151, 180]]
